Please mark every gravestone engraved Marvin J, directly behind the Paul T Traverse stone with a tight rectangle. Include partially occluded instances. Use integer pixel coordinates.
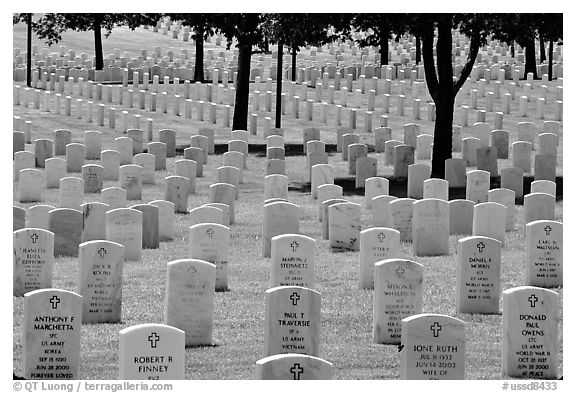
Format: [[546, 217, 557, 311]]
[[270, 234, 316, 289]]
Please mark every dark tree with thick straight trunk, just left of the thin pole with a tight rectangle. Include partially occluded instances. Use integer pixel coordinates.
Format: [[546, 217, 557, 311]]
[[214, 14, 264, 130]]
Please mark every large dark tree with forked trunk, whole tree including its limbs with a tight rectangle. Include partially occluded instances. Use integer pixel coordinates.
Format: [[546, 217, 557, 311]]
[[408, 14, 493, 178]]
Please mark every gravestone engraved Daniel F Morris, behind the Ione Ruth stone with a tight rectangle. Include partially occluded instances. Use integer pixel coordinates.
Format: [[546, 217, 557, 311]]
[[456, 236, 502, 314]]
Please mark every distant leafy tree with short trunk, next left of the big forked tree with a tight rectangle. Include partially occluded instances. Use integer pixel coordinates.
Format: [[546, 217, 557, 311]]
[[351, 13, 408, 65]]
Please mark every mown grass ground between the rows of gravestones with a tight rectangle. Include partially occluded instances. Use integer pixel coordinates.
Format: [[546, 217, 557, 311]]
[[13, 23, 563, 380]]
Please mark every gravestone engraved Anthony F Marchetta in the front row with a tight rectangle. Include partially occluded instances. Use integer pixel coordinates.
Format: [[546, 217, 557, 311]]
[[22, 289, 82, 380]]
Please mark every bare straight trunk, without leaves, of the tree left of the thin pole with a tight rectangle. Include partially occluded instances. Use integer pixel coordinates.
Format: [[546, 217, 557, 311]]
[[232, 43, 252, 131]]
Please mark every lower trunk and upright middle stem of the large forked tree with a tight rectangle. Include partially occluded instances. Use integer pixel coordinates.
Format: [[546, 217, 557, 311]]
[[430, 18, 454, 179]]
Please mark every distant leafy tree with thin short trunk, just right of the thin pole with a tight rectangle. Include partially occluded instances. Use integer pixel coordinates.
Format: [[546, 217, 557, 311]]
[[262, 14, 350, 81]]
